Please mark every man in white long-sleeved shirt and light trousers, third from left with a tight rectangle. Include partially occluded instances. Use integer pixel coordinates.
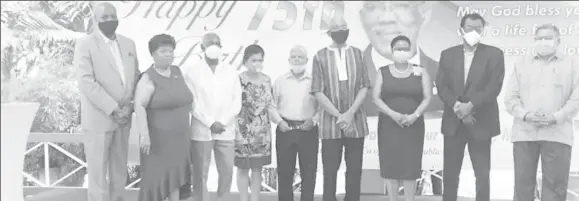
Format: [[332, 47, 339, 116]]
[[184, 33, 241, 201]]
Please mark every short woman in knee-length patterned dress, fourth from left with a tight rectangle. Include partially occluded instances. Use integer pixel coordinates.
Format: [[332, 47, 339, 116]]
[[235, 45, 274, 201]]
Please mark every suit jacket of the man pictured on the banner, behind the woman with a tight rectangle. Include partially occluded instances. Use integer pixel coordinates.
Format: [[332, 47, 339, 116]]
[[363, 45, 444, 119]]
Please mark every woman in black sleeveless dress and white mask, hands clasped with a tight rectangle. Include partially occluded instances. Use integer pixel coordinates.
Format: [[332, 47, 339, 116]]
[[373, 36, 432, 201]]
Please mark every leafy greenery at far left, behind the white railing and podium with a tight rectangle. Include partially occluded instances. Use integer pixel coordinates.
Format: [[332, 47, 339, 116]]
[[1, 1, 138, 186]]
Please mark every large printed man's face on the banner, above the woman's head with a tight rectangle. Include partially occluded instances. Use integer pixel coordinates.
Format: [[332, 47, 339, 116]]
[[360, 1, 430, 56]]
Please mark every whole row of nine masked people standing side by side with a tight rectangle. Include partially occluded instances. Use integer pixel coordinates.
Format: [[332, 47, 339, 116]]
[[74, 3, 579, 201]]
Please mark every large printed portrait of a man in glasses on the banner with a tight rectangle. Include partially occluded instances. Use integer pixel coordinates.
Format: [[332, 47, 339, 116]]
[[359, 1, 442, 119]]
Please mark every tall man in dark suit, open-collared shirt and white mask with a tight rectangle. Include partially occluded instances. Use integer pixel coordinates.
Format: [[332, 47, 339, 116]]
[[436, 13, 505, 201]]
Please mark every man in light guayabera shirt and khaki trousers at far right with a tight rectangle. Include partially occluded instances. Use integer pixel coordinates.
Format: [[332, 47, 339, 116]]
[[505, 24, 579, 201]]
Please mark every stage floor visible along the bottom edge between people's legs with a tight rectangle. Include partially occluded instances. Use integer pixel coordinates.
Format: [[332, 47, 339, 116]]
[[26, 189, 507, 201]]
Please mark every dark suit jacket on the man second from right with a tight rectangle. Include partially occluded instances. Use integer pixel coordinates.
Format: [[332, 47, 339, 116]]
[[436, 44, 505, 139]]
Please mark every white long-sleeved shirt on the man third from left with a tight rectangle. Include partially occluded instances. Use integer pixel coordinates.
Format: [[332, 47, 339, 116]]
[[184, 60, 241, 141]]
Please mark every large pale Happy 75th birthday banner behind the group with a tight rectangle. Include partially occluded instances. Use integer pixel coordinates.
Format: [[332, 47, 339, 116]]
[[112, 1, 579, 171]]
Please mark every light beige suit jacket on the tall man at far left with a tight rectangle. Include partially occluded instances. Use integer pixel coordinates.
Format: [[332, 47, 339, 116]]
[[74, 31, 140, 132]]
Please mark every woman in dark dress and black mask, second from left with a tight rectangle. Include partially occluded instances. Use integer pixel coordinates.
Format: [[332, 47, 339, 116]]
[[135, 34, 193, 201]]
